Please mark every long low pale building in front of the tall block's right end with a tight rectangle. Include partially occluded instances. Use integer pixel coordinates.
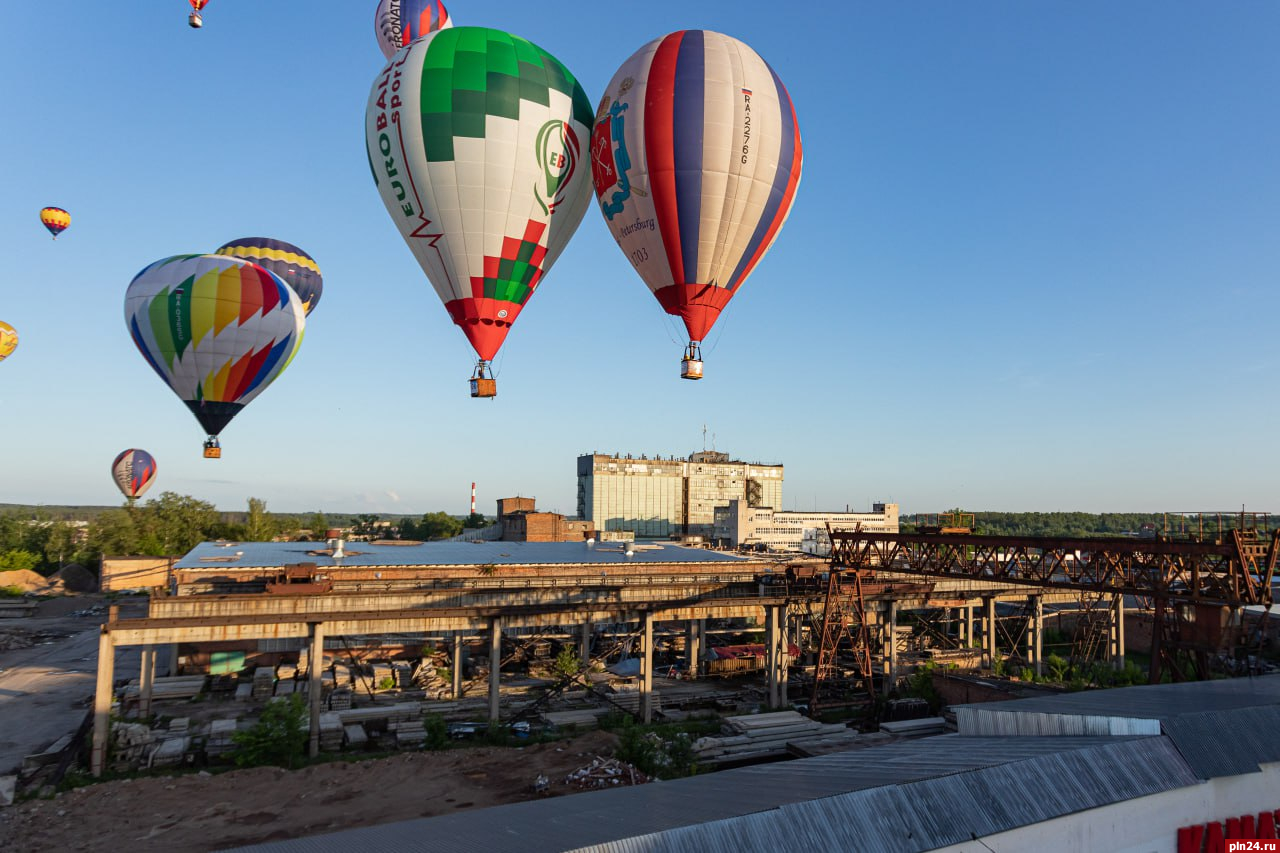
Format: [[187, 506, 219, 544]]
[[712, 501, 897, 556]]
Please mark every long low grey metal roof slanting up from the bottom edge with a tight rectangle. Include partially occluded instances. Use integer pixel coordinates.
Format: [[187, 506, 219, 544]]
[[227, 735, 1172, 853]]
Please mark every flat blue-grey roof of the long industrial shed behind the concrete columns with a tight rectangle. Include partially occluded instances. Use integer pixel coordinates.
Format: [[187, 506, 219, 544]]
[[174, 542, 750, 570]]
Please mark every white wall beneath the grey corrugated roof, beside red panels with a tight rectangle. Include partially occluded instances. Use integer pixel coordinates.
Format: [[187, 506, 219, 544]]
[[937, 763, 1280, 853]]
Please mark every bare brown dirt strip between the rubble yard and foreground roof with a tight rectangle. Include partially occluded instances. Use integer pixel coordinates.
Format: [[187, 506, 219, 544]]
[[0, 731, 617, 853]]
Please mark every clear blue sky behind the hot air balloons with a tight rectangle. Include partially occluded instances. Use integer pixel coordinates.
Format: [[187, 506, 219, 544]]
[[0, 0, 1280, 514]]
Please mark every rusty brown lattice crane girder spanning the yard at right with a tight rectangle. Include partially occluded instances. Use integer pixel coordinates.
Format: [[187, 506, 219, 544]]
[[831, 514, 1280, 683]]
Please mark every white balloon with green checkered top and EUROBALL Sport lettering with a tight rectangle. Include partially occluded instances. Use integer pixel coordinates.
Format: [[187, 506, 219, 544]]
[[365, 27, 591, 397]]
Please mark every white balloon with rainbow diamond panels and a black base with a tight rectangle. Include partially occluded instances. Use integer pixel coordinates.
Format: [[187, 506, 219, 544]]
[[124, 255, 306, 459]]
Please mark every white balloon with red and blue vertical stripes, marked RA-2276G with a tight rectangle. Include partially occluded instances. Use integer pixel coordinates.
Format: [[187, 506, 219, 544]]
[[591, 29, 803, 379]]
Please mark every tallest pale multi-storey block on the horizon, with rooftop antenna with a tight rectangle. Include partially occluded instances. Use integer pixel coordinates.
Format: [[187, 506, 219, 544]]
[[577, 451, 782, 538]]
